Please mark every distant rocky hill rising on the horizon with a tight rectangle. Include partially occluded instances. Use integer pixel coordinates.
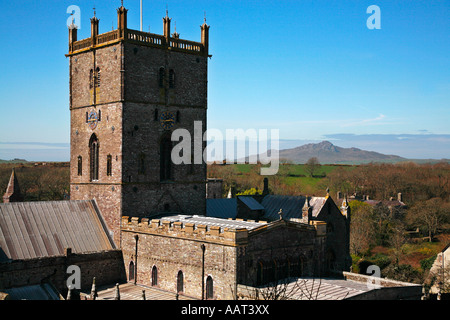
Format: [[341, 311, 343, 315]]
[[279, 141, 409, 164]]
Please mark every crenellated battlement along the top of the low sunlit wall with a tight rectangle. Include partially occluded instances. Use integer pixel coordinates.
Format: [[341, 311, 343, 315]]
[[121, 216, 253, 245]]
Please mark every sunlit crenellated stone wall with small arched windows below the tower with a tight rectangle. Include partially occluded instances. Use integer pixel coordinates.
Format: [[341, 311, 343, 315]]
[[122, 217, 239, 299]]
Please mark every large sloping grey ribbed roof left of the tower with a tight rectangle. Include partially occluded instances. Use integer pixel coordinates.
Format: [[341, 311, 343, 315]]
[[0, 200, 115, 262]]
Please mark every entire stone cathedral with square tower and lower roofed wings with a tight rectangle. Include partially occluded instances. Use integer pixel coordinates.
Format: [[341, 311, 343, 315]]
[[0, 5, 356, 299]]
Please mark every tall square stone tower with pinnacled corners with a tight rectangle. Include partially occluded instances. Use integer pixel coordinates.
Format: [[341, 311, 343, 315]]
[[66, 5, 210, 246]]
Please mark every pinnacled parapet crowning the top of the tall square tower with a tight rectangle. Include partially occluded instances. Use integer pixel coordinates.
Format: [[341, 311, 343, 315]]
[[67, 7, 209, 56]]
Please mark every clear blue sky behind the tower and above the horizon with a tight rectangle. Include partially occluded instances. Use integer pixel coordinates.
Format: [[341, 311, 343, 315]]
[[0, 0, 450, 161]]
